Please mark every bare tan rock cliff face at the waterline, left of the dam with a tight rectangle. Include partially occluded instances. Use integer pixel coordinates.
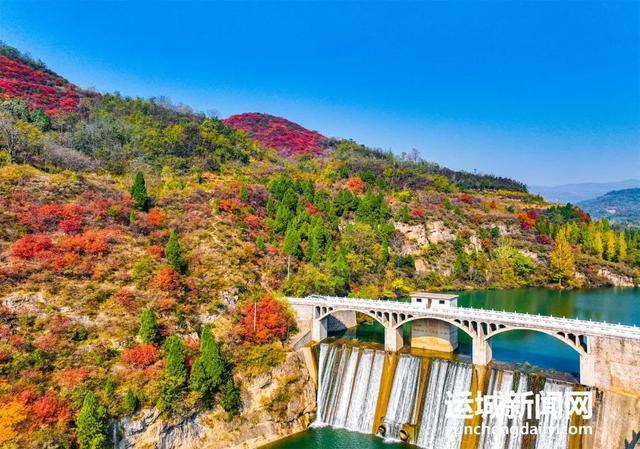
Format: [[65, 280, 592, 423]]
[[113, 352, 316, 449]]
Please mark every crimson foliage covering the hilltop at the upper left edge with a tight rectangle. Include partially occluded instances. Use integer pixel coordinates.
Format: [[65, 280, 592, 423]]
[[0, 55, 87, 115]]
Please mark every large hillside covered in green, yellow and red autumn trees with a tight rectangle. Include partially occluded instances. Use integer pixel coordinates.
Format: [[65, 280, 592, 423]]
[[0, 43, 640, 448]]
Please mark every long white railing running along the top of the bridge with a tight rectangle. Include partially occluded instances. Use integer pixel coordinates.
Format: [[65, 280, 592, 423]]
[[288, 295, 640, 339]]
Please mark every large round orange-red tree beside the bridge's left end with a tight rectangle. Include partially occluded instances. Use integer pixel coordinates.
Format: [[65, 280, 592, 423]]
[[240, 295, 291, 344]]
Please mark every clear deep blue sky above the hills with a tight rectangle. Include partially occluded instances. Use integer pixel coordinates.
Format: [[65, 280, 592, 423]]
[[0, 0, 640, 185]]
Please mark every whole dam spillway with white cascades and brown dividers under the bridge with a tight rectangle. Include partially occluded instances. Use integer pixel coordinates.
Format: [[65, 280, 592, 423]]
[[316, 343, 574, 449]]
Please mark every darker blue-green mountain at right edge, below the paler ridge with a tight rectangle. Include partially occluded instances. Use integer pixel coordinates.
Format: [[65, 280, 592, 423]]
[[578, 189, 640, 226]]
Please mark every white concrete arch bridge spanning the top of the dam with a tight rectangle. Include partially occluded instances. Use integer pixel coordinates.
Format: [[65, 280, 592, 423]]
[[287, 293, 640, 393]]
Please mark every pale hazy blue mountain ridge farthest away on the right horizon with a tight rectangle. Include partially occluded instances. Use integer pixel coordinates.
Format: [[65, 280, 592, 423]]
[[529, 179, 640, 204]]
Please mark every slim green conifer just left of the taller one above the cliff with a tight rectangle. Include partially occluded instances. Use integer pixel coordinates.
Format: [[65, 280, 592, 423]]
[[158, 335, 187, 411]]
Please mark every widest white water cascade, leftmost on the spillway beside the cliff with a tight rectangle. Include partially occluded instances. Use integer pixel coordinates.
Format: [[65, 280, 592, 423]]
[[316, 344, 384, 433]]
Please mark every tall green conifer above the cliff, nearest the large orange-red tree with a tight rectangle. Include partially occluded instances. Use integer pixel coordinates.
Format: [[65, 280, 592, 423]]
[[190, 324, 224, 407]]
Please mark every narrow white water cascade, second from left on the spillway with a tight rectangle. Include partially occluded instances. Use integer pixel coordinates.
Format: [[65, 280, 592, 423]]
[[384, 354, 422, 440]]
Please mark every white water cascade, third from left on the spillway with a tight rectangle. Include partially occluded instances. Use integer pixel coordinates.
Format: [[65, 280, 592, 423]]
[[416, 359, 472, 449]]
